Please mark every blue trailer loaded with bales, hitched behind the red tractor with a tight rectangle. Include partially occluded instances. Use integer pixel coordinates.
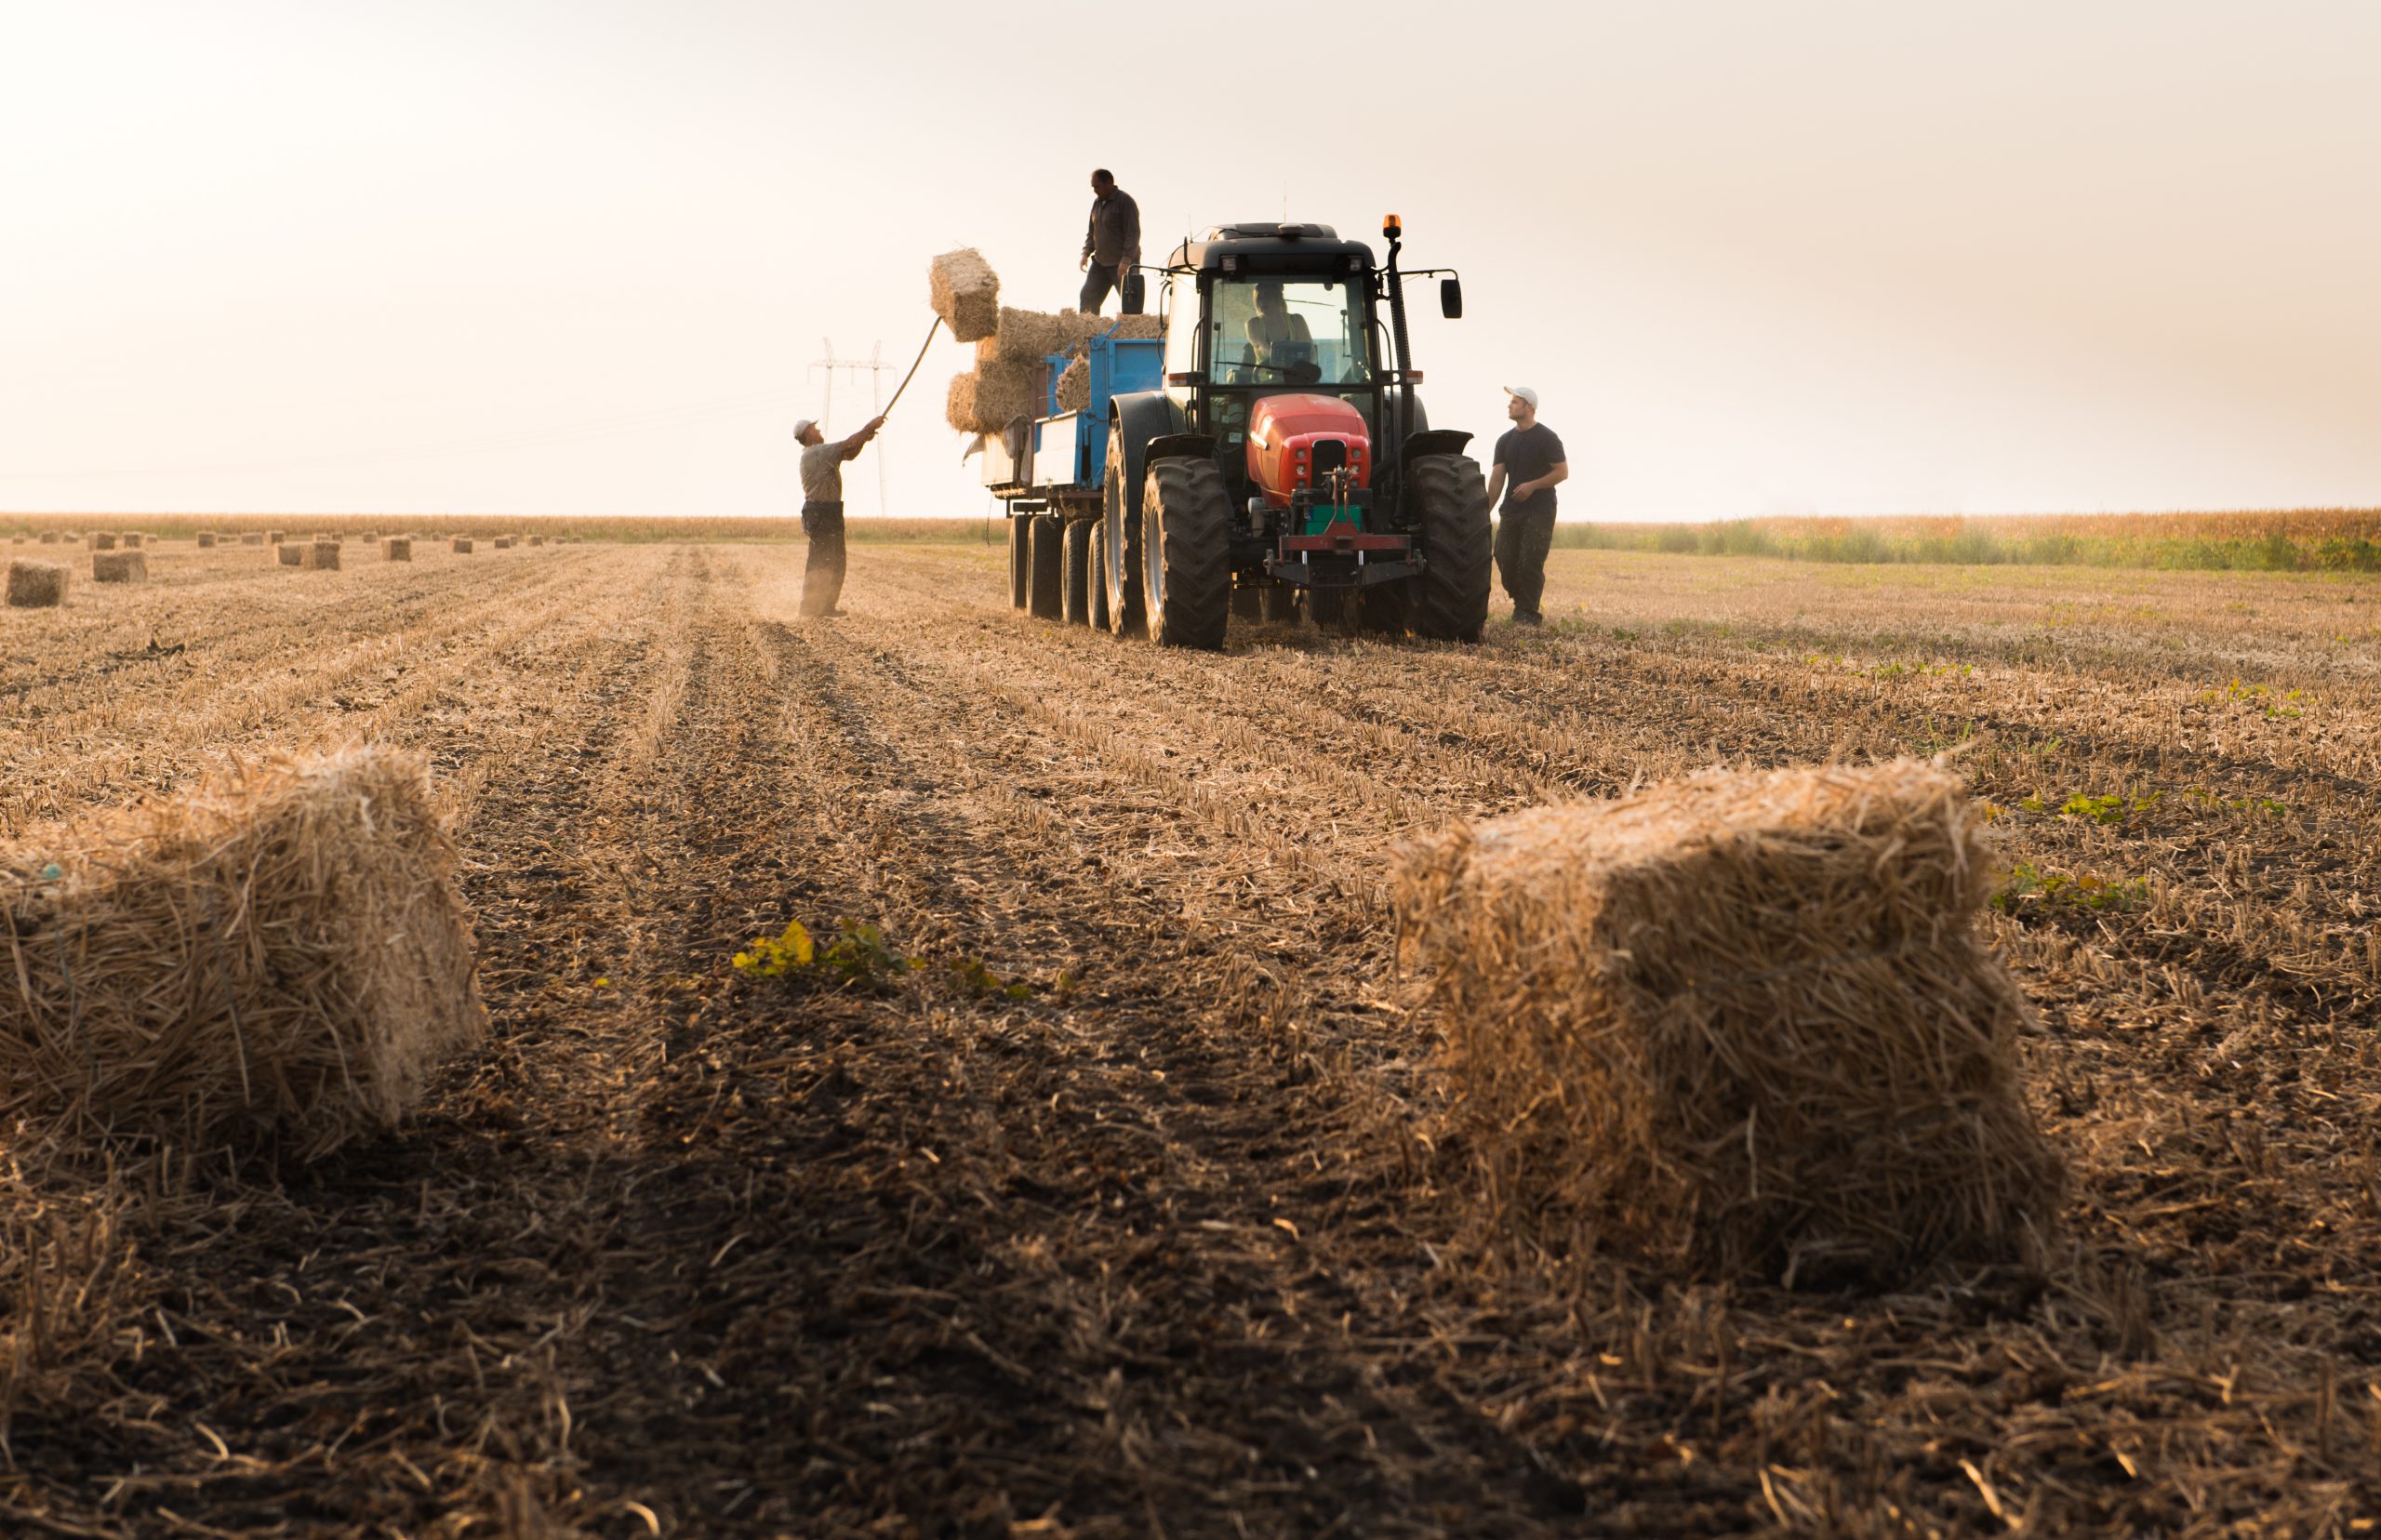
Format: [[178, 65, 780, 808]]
[[983, 328, 1164, 626]]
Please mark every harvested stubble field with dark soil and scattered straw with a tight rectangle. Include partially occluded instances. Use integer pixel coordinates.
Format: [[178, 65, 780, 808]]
[[0, 535, 2381, 1537]]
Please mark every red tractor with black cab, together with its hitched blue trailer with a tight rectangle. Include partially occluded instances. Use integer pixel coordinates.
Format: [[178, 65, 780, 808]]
[[988, 214, 1493, 647]]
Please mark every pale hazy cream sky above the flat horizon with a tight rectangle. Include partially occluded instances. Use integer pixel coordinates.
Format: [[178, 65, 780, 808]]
[[0, 0, 2381, 519]]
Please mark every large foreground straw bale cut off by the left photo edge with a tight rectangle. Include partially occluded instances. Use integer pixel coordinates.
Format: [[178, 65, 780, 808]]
[[0, 750, 486, 1157]]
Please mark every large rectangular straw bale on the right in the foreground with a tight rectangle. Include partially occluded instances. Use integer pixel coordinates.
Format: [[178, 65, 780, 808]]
[[1398, 762, 2065, 1285]]
